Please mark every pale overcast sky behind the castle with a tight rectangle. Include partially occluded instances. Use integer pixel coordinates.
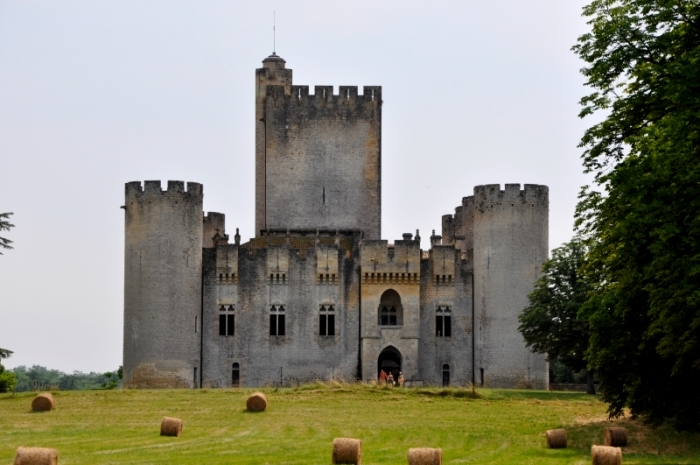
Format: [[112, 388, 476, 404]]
[[0, 0, 591, 372]]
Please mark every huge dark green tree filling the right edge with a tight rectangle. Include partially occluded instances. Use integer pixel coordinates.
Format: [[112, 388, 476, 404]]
[[573, 0, 700, 429]]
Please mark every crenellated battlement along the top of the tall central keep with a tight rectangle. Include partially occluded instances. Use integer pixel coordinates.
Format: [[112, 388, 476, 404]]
[[266, 85, 382, 108]]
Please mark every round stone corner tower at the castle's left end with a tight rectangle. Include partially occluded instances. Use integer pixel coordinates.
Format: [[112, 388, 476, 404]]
[[123, 181, 203, 388]]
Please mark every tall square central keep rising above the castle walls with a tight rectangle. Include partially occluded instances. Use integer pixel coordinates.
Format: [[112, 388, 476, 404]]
[[255, 54, 382, 240]]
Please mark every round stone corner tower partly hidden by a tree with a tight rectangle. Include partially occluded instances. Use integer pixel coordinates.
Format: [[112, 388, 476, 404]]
[[473, 184, 549, 389]]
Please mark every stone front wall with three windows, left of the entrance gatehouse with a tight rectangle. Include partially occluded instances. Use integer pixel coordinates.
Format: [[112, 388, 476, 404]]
[[203, 232, 360, 387]]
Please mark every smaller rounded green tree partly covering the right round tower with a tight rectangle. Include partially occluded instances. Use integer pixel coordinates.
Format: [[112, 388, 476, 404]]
[[518, 237, 595, 394]]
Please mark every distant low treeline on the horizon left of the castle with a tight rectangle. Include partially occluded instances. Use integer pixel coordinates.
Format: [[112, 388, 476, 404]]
[[8, 365, 121, 392]]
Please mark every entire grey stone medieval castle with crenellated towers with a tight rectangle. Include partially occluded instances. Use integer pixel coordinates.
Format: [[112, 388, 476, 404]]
[[123, 53, 549, 389]]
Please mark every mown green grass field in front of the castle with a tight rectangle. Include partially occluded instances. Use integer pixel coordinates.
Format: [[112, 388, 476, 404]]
[[0, 383, 700, 465]]
